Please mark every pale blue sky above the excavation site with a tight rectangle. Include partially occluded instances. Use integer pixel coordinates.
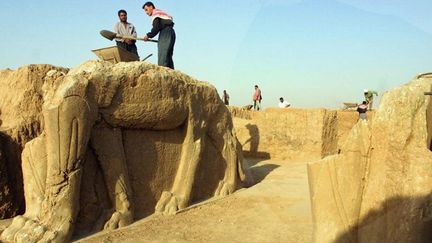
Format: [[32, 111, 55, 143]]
[[0, 0, 432, 108]]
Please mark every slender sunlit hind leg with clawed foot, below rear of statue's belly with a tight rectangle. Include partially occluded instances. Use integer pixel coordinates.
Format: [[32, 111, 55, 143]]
[[156, 118, 205, 214]]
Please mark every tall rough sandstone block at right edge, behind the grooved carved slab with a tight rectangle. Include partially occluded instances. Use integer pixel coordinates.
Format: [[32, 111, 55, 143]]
[[358, 76, 432, 242]]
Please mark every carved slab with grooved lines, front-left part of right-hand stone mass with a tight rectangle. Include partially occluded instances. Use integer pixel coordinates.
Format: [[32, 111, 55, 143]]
[[308, 121, 370, 242]]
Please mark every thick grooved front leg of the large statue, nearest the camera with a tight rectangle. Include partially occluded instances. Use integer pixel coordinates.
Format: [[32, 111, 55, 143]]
[[14, 96, 97, 242]]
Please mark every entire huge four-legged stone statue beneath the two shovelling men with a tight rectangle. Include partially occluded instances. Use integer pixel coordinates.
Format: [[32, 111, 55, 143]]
[[2, 61, 244, 242]]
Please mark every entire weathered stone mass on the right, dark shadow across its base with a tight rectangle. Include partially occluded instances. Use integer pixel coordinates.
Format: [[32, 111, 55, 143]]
[[309, 75, 432, 242]]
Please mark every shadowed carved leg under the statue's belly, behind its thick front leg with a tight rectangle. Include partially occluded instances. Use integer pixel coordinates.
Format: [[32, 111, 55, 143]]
[[91, 124, 133, 229]]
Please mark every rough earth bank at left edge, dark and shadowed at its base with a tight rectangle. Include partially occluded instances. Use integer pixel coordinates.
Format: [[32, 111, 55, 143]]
[[0, 65, 68, 219]]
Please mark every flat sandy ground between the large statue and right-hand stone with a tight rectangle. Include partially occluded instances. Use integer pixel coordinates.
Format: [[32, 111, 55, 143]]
[[78, 160, 312, 243]]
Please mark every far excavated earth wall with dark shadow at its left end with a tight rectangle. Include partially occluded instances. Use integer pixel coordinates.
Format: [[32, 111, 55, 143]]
[[231, 108, 358, 161]]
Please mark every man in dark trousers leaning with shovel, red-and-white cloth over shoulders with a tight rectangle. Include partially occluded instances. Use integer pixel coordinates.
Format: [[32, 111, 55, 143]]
[[143, 2, 176, 69]]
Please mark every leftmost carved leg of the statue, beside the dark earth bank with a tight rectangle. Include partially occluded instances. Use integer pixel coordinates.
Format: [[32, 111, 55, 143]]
[[0, 134, 47, 242]]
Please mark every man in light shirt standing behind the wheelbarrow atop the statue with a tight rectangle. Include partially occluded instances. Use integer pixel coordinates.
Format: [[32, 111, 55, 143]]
[[114, 9, 138, 56]]
